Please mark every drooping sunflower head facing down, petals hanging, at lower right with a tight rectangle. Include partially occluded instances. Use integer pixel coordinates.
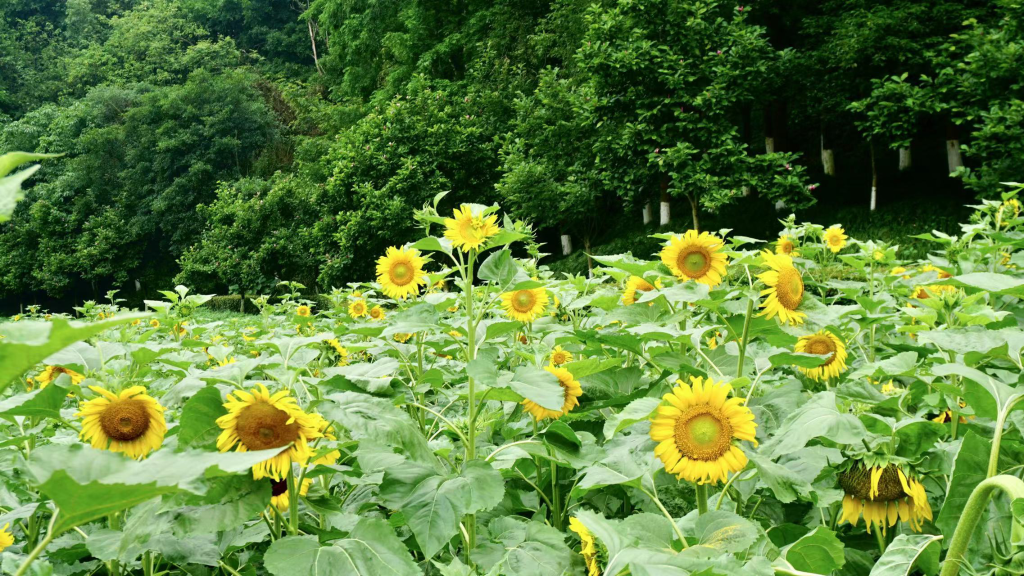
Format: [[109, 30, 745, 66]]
[[839, 461, 932, 534]]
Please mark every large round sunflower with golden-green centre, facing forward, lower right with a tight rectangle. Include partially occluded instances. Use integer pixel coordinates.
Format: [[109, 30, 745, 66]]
[[650, 376, 758, 484]]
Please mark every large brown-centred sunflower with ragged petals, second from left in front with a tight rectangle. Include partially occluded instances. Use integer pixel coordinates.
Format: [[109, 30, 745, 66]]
[[217, 384, 323, 480]]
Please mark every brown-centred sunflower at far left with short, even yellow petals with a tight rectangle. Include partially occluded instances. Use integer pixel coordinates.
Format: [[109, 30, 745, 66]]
[[76, 386, 167, 459]]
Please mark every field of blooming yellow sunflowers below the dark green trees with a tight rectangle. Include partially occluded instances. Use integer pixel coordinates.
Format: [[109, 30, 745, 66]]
[[6, 186, 1024, 576]]
